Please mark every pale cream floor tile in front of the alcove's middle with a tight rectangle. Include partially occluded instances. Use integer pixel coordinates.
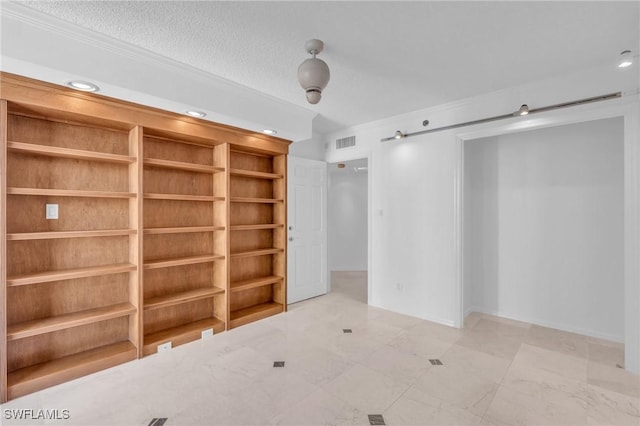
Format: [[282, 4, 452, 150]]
[[512, 344, 587, 382]]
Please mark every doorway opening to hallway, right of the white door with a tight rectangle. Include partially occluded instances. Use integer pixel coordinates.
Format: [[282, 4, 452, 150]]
[[327, 158, 369, 303]]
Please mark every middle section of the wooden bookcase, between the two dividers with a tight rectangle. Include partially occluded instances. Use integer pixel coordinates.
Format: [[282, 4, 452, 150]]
[[142, 130, 227, 354]]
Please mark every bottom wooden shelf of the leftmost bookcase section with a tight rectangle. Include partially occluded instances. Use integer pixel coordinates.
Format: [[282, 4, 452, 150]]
[[7, 342, 137, 399]]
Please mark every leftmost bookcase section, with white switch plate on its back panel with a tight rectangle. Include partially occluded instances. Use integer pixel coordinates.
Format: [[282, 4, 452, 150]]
[[0, 98, 139, 400]]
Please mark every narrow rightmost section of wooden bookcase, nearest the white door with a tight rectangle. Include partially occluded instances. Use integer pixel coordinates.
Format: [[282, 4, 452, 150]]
[[229, 150, 286, 328]]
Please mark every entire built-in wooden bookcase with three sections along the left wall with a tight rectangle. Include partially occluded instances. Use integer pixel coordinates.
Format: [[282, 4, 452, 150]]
[[0, 73, 289, 403]]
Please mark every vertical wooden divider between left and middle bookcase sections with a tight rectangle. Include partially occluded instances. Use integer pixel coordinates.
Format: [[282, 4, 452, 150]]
[[129, 126, 144, 358]]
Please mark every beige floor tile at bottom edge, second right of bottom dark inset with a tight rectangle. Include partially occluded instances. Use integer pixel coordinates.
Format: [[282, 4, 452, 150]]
[[484, 387, 587, 426]]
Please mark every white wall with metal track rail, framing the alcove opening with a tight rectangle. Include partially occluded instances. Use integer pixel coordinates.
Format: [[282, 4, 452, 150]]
[[326, 64, 640, 372]]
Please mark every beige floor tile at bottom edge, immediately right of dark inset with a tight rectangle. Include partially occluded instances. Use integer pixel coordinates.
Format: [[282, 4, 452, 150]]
[[384, 388, 482, 426]]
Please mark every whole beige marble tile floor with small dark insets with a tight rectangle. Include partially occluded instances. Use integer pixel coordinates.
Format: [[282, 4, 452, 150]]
[[0, 273, 640, 426]]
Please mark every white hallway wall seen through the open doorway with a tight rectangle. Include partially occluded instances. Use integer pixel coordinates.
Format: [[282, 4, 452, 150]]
[[327, 170, 368, 271]]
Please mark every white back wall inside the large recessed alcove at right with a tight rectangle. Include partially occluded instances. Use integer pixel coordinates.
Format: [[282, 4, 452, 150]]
[[464, 117, 624, 341]]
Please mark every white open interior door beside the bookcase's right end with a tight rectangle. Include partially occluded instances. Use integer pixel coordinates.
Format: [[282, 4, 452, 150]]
[[287, 156, 328, 303]]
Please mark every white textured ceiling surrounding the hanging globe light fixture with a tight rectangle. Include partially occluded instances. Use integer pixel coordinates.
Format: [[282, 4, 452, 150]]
[[8, 1, 640, 133]]
